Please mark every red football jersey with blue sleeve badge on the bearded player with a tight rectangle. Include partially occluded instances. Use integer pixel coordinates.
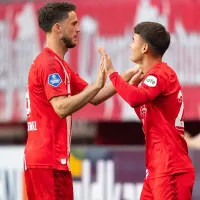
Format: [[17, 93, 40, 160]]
[[25, 48, 88, 170]]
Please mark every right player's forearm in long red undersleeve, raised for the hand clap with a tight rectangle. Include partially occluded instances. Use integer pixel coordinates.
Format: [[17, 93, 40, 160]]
[[110, 72, 149, 107]]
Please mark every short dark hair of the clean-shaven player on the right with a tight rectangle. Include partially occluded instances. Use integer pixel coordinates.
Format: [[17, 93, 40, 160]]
[[134, 22, 170, 56]]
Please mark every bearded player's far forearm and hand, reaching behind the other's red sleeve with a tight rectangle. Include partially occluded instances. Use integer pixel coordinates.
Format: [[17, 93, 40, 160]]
[[90, 72, 134, 105]]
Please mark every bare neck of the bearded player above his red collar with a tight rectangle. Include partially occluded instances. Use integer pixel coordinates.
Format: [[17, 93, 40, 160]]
[[47, 35, 68, 59]]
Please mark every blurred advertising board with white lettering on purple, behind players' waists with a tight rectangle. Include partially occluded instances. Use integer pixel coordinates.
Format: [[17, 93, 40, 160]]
[[0, 146, 200, 200]]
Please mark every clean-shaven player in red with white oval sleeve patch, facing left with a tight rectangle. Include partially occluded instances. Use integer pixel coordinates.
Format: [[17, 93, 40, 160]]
[[99, 22, 195, 200]]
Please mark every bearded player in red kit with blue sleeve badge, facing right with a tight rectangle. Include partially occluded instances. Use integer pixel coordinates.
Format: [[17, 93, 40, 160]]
[[24, 2, 137, 200]]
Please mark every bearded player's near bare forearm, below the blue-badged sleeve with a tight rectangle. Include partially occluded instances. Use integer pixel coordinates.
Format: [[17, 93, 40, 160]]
[[57, 84, 101, 118]]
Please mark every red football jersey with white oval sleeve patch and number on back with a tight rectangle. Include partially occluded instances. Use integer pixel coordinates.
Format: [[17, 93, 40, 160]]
[[135, 63, 194, 178]]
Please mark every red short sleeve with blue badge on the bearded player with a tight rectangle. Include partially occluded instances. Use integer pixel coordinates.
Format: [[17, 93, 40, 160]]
[[40, 60, 70, 100]]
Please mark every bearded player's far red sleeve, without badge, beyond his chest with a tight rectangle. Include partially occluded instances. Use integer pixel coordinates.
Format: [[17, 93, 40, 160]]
[[71, 72, 88, 95]]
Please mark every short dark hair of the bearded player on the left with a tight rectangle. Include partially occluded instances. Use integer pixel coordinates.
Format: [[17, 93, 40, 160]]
[[37, 2, 76, 33]]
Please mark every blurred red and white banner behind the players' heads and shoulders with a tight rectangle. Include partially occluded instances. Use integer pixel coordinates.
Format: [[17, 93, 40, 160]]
[[0, 0, 200, 122]]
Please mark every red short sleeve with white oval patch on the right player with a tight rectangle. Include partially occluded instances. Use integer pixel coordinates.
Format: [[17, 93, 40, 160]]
[[139, 73, 168, 100]]
